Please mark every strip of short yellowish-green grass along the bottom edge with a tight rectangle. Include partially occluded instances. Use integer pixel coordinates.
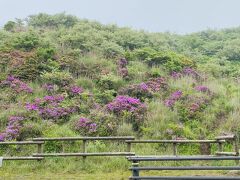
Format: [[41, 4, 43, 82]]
[[0, 167, 239, 180]]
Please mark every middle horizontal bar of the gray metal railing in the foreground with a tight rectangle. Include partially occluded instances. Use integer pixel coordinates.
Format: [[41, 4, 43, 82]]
[[129, 166, 240, 170]]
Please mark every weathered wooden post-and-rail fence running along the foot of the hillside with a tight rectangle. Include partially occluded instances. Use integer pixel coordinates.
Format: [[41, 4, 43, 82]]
[[0, 135, 239, 160]]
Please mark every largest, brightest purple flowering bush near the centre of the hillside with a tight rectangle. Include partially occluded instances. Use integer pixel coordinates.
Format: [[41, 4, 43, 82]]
[[106, 96, 147, 130]]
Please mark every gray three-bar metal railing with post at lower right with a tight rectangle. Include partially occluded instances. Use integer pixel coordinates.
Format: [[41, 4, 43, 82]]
[[127, 156, 240, 180]]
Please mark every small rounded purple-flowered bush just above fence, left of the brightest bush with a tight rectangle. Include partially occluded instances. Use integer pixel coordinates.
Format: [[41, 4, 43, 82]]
[[75, 117, 97, 135]]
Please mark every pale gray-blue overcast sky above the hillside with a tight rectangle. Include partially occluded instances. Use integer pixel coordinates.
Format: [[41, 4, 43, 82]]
[[0, 0, 240, 34]]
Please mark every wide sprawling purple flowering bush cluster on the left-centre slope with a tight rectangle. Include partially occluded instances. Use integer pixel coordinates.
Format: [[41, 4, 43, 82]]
[[26, 95, 75, 120]]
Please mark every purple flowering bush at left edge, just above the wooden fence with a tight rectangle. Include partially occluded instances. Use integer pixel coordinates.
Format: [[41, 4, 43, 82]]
[[0, 116, 25, 141]]
